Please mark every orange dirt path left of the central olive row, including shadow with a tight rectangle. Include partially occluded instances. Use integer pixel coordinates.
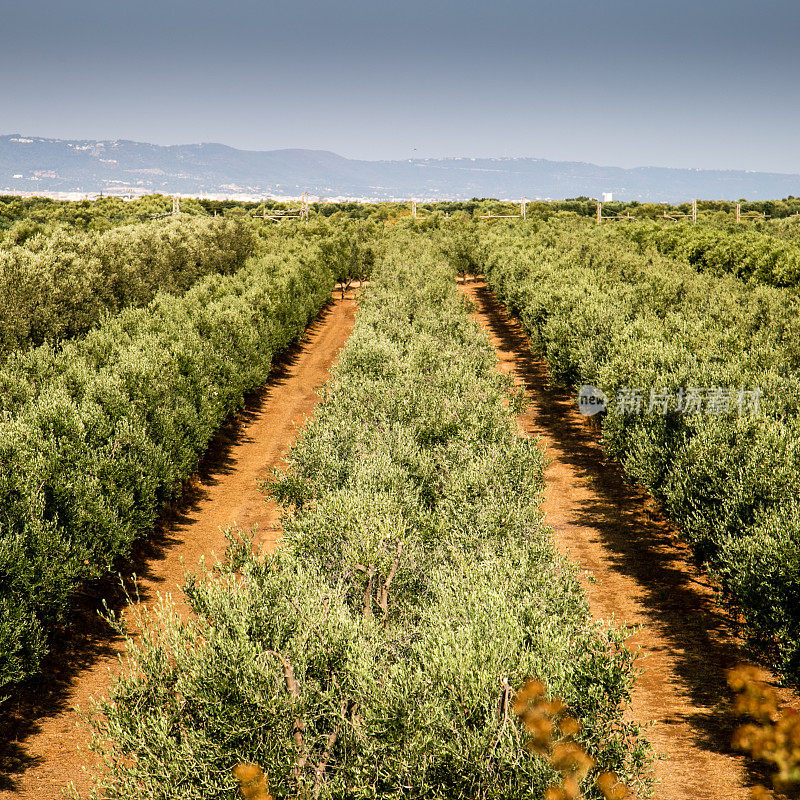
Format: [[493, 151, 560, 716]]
[[0, 292, 355, 800]]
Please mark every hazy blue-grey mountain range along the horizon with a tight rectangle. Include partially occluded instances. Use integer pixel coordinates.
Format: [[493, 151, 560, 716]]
[[0, 134, 800, 202]]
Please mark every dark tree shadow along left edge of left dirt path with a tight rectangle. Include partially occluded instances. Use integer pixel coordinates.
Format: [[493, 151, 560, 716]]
[[0, 302, 340, 792]]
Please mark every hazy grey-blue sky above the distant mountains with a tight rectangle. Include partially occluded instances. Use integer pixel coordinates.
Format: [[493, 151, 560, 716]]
[[0, 0, 800, 172]]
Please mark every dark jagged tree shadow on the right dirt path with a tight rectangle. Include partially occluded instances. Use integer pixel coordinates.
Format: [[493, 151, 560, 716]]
[[471, 282, 765, 782]]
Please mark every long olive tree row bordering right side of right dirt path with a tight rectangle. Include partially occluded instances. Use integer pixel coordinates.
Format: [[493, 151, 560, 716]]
[[476, 217, 800, 682]]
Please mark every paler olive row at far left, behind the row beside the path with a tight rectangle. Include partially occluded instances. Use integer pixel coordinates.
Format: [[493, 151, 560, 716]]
[[0, 217, 255, 360]]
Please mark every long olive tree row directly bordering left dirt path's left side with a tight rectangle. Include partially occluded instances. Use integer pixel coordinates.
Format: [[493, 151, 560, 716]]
[[0, 234, 332, 686]]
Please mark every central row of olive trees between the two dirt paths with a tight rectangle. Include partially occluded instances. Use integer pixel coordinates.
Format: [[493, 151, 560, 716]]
[[87, 232, 647, 800]]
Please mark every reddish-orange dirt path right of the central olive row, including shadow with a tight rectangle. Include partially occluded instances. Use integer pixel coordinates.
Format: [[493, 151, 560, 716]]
[[463, 283, 768, 800]]
